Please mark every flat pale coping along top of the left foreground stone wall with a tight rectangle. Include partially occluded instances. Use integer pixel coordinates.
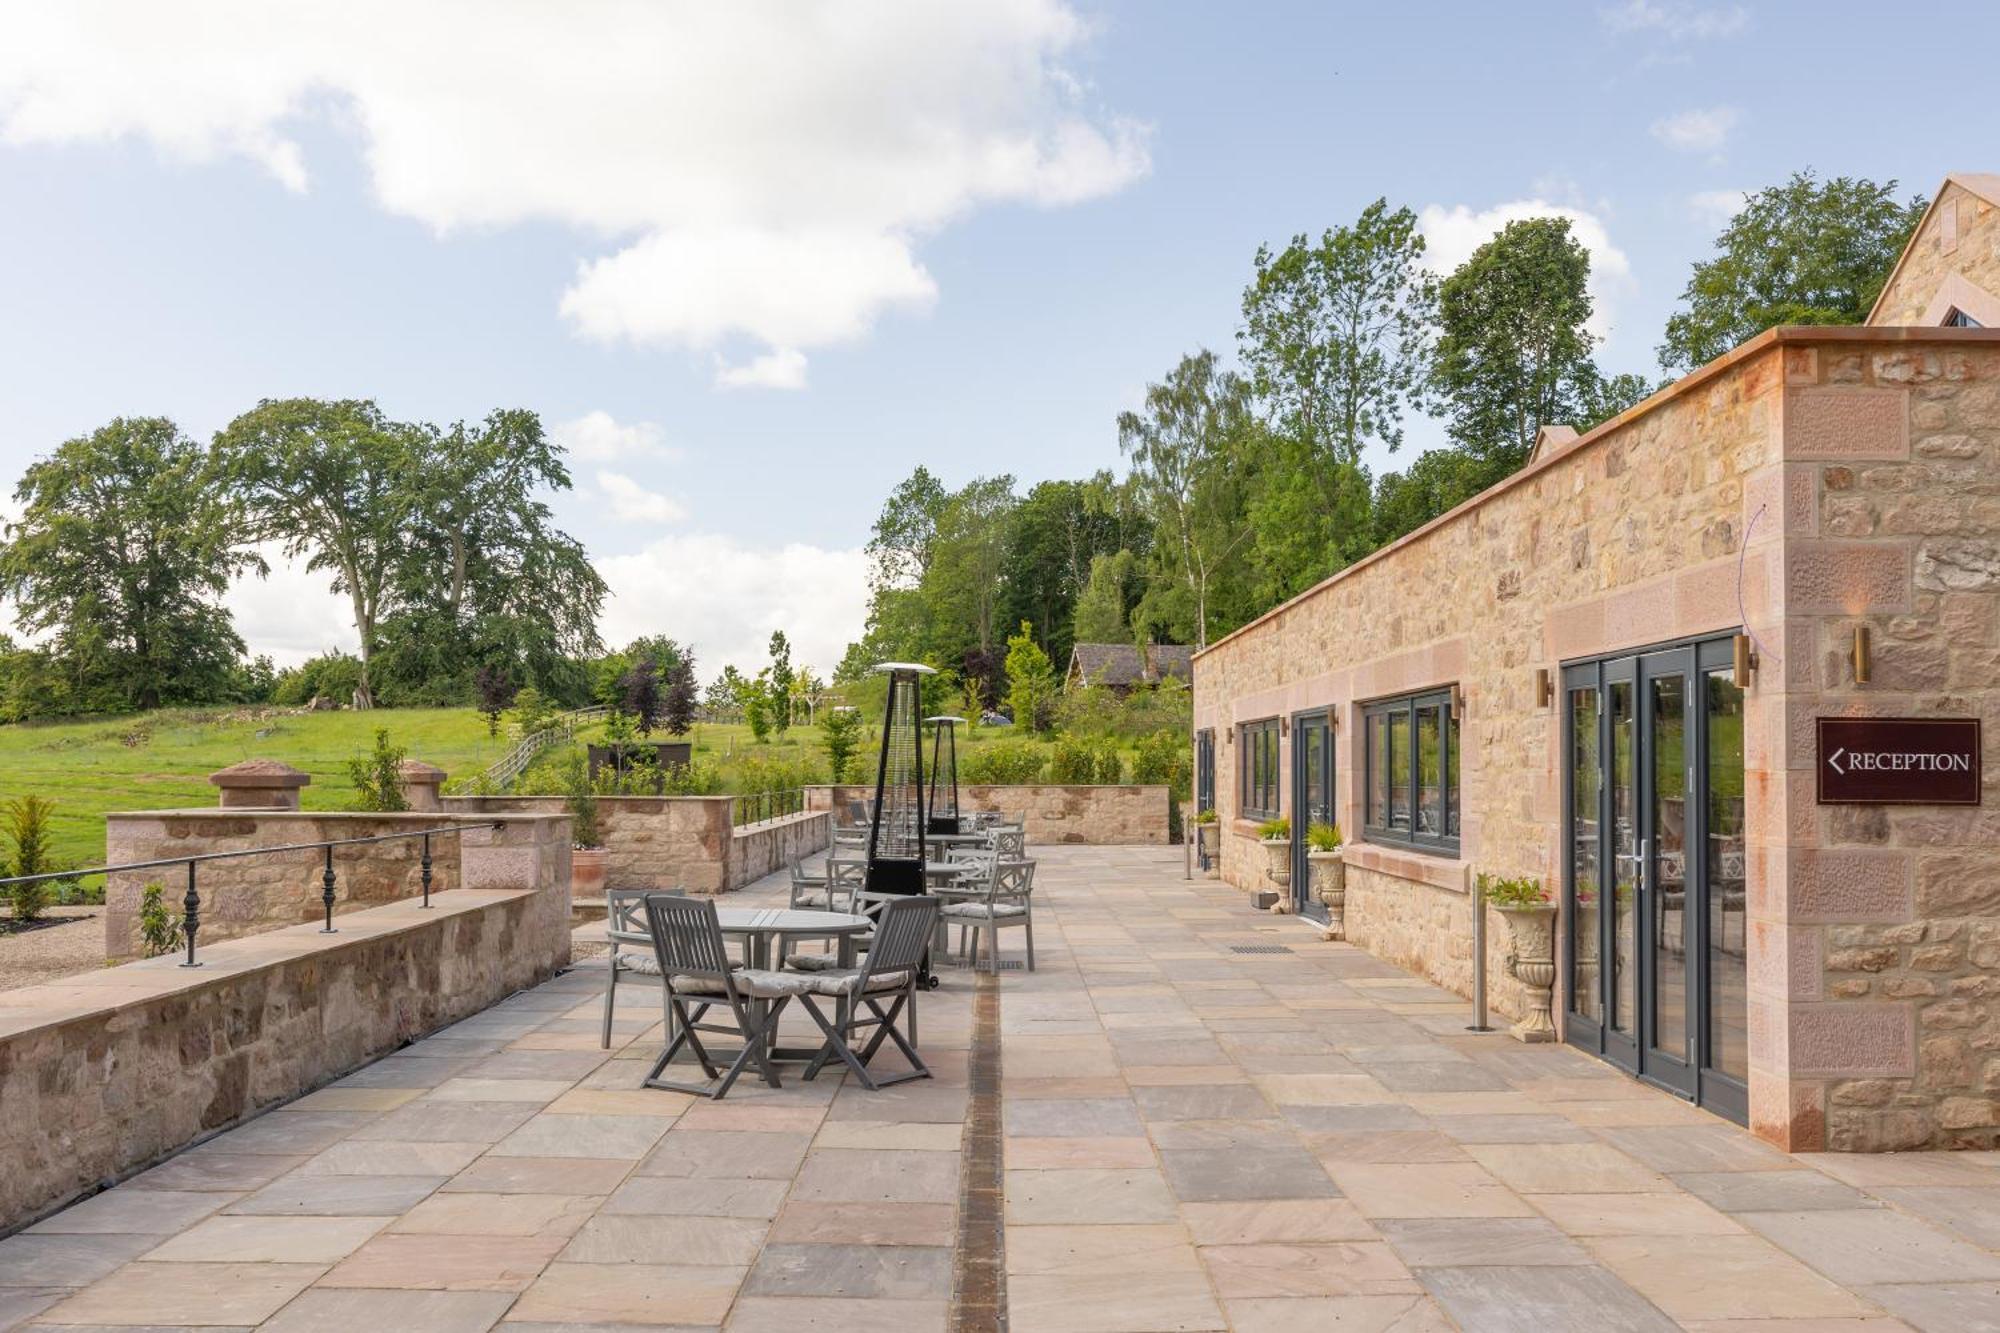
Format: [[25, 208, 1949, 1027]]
[[0, 889, 540, 1041]]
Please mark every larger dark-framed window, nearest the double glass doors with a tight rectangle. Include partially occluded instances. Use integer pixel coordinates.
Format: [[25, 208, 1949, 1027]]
[[1362, 691, 1458, 855]]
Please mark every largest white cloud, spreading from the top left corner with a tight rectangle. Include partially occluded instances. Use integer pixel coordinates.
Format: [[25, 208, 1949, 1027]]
[[0, 0, 1150, 386]]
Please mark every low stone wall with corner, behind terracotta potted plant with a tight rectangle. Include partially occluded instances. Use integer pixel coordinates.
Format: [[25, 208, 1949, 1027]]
[[442, 797, 832, 895]]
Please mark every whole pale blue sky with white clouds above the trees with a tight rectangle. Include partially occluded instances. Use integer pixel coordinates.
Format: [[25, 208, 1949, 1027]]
[[0, 0, 2000, 675]]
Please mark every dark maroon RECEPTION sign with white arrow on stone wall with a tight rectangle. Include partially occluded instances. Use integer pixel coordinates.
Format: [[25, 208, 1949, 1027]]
[[1818, 717, 1980, 805]]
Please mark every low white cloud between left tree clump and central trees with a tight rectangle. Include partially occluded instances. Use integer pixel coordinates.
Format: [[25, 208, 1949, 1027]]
[[596, 534, 868, 681]]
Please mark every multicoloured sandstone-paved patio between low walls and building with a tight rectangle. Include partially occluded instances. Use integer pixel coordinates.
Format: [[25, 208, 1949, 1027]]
[[0, 847, 2000, 1333]]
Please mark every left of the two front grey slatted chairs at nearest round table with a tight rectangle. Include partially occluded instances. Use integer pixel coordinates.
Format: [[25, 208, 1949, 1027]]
[[646, 893, 812, 1101]]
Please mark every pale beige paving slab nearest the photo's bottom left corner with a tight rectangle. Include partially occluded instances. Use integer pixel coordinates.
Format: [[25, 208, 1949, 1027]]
[[40, 1263, 326, 1325]]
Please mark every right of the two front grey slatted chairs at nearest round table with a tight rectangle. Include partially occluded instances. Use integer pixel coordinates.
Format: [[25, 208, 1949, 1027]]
[[798, 897, 938, 1093]]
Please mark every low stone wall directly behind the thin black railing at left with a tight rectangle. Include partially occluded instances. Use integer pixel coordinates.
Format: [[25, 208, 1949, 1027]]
[[104, 809, 488, 963]]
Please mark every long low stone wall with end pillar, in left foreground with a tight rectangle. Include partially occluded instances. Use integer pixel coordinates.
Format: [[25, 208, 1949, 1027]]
[[0, 819, 570, 1235]]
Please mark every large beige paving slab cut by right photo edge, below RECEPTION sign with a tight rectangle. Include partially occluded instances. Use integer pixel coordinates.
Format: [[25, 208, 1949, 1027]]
[[1736, 1209, 2000, 1287]]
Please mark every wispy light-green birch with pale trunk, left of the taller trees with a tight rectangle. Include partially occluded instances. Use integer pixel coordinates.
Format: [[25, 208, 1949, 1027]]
[[1120, 350, 1254, 644]]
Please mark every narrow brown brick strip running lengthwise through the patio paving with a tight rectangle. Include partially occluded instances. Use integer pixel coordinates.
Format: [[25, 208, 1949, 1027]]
[[950, 973, 1006, 1333]]
